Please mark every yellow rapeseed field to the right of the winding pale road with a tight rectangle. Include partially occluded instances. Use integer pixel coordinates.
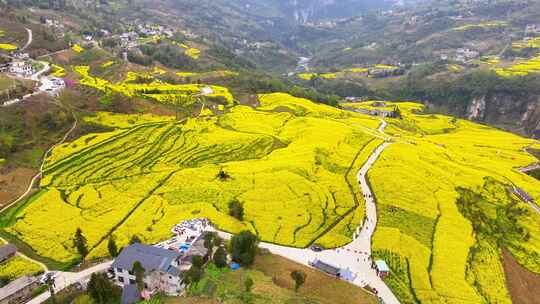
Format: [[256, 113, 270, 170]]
[[349, 103, 540, 303]]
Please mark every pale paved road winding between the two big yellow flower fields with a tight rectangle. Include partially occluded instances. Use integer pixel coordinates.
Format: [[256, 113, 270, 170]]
[[219, 121, 399, 304]]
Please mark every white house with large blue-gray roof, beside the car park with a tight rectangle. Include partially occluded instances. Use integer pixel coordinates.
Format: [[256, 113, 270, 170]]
[[112, 243, 184, 295]]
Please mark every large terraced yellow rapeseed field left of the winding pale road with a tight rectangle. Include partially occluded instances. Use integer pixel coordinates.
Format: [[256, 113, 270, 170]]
[[3, 94, 380, 262]]
